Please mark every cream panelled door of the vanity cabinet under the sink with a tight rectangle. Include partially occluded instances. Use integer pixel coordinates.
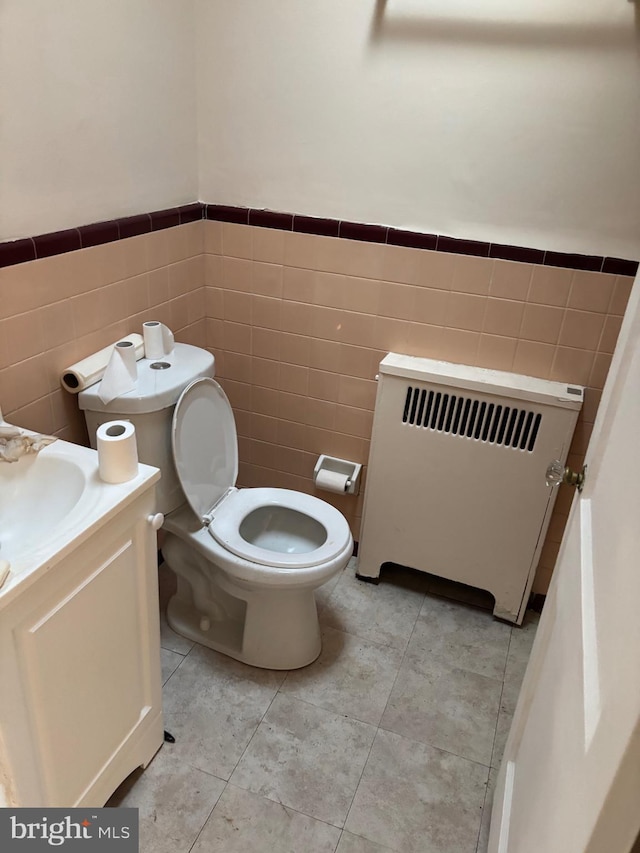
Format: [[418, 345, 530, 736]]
[[14, 531, 154, 806]]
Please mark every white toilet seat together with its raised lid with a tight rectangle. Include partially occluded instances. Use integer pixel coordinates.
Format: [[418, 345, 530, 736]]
[[171, 377, 351, 569]]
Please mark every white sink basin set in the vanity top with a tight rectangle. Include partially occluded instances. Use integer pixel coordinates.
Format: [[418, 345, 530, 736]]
[[0, 445, 89, 563]]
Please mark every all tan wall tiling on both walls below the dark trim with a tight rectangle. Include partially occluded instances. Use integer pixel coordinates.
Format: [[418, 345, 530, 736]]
[[0, 213, 633, 592]]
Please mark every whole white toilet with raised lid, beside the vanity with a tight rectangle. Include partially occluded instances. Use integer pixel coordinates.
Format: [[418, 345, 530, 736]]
[[80, 344, 353, 669]]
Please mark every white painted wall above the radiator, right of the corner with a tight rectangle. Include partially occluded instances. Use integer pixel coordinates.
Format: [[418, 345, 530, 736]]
[[196, 0, 640, 258]]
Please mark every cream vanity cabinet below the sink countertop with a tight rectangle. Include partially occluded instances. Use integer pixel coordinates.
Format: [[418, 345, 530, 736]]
[[0, 480, 163, 807]]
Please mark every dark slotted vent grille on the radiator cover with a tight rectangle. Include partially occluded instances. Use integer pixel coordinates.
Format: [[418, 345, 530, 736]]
[[402, 385, 542, 452]]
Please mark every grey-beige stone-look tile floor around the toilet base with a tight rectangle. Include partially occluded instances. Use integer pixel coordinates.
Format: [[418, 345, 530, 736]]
[[108, 561, 537, 853]]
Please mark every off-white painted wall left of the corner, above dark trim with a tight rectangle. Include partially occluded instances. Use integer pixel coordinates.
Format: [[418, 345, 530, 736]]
[[0, 0, 198, 240]]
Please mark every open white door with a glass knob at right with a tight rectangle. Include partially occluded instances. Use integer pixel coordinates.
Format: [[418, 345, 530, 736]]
[[489, 275, 640, 853]]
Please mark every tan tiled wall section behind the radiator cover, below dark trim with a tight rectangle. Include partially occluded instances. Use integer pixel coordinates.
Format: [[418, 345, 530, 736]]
[[204, 221, 633, 592]]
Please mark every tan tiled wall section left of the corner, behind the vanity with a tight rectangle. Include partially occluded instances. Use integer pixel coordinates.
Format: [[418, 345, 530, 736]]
[[0, 221, 205, 444]]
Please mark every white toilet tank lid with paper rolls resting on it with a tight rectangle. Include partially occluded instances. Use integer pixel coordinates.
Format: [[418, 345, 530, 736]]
[[78, 344, 215, 415]]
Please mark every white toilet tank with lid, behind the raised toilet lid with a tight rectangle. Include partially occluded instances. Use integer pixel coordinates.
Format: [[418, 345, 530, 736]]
[[78, 344, 215, 514]]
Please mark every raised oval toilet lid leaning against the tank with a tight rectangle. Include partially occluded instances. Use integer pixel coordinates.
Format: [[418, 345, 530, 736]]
[[171, 377, 238, 519]]
